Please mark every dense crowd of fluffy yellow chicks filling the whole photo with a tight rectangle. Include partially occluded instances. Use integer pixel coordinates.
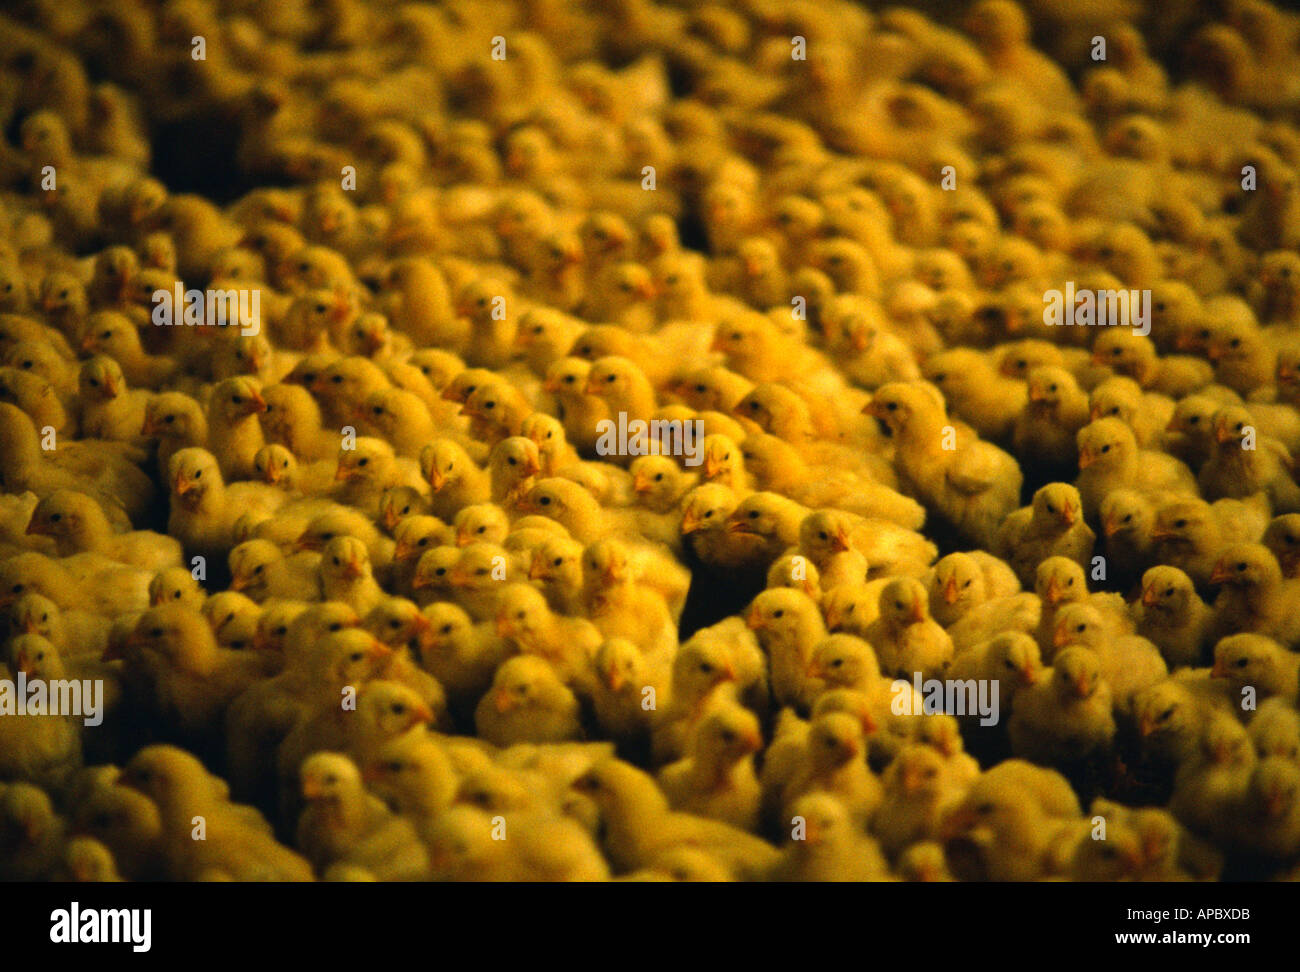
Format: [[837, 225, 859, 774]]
[[0, 0, 1300, 881]]
